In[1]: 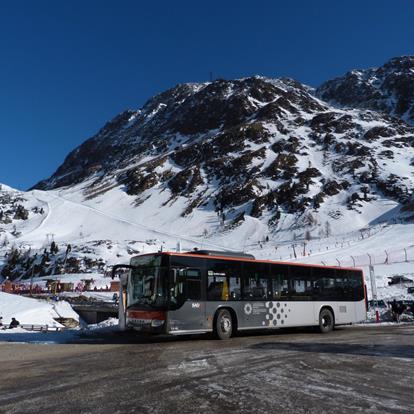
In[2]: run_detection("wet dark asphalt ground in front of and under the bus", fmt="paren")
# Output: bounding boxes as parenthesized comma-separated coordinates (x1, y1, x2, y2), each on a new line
(0, 324, 414, 414)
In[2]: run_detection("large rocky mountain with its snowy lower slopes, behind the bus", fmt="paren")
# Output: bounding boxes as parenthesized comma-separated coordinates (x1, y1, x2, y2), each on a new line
(0, 57, 414, 300)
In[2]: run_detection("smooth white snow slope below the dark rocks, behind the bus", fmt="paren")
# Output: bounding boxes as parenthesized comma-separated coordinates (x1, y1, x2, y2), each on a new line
(0, 183, 414, 297)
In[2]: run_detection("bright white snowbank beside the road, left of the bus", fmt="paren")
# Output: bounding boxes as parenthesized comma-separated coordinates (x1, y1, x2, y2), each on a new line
(0, 292, 79, 326)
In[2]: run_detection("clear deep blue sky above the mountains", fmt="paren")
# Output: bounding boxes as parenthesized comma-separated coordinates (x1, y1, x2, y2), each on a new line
(0, 0, 414, 189)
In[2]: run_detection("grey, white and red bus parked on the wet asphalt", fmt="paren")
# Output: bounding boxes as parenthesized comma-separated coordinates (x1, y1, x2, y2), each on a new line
(113, 250, 366, 339)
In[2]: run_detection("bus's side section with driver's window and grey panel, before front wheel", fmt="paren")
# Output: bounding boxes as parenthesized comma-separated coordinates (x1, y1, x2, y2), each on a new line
(169, 268, 207, 333)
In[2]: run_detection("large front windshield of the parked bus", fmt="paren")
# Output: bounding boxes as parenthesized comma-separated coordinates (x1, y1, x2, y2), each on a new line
(127, 256, 167, 307)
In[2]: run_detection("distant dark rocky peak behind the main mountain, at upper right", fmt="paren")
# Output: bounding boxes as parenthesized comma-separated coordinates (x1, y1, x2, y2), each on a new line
(316, 56, 414, 124)
